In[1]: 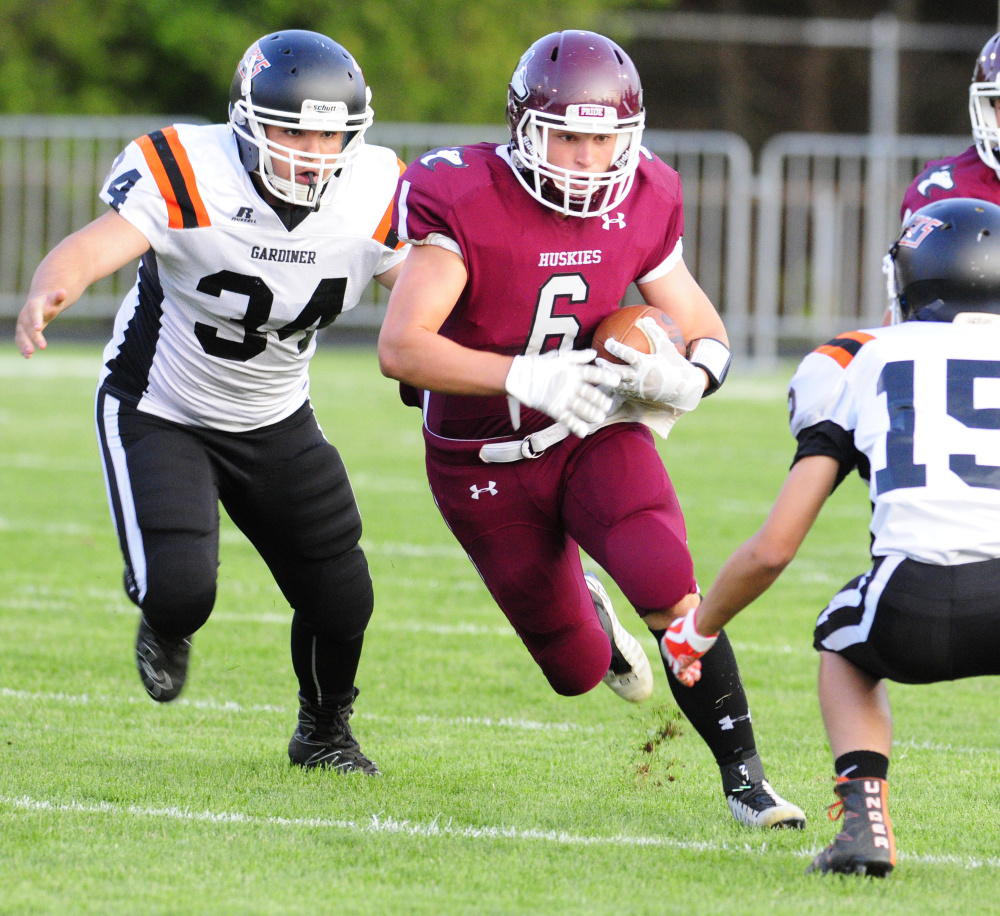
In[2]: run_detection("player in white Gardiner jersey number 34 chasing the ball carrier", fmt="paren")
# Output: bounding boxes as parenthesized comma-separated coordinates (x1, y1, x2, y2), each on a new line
(16, 30, 406, 774)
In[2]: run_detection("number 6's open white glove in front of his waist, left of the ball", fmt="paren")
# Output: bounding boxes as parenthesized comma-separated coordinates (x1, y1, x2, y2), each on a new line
(505, 350, 621, 439)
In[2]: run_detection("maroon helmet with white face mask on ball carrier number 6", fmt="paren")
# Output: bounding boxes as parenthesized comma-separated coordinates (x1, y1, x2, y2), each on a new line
(507, 32, 646, 216)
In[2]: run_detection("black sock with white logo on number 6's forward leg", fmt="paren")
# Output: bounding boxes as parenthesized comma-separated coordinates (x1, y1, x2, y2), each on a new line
(650, 629, 757, 767)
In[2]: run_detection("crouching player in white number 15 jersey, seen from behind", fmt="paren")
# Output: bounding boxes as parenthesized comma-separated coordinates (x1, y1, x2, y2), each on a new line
(664, 198, 1000, 876)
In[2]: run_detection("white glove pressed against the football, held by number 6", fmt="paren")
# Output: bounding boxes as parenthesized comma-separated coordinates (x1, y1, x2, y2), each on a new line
(601, 318, 705, 411)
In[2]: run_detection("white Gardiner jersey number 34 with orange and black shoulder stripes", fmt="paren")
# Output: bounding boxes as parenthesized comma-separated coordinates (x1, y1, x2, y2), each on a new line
(94, 124, 406, 432)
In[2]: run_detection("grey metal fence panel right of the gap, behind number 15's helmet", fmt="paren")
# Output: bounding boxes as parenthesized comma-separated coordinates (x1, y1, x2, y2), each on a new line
(751, 134, 970, 361)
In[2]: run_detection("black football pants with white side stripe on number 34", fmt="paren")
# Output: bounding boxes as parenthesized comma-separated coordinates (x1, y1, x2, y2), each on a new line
(96, 390, 374, 701)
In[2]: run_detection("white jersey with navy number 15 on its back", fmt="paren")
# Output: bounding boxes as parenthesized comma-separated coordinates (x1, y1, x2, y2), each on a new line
(789, 315, 1000, 565)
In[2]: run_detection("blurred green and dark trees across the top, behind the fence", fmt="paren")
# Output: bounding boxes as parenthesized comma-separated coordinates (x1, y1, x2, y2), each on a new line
(0, 0, 997, 143)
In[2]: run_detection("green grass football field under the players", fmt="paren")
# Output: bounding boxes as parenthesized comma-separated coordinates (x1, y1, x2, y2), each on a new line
(0, 340, 1000, 916)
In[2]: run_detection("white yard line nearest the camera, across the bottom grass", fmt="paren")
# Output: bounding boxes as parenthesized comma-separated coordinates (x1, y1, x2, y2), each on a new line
(0, 795, 1000, 869)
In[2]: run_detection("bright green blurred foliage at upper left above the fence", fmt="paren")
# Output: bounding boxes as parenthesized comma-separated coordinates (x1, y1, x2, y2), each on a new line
(0, 0, 675, 123)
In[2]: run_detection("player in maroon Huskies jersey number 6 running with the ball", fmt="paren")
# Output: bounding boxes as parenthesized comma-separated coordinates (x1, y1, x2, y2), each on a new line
(379, 31, 805, 827)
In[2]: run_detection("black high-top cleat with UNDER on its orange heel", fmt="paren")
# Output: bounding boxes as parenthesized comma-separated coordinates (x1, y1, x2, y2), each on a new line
(806, 778, 896, 878)
